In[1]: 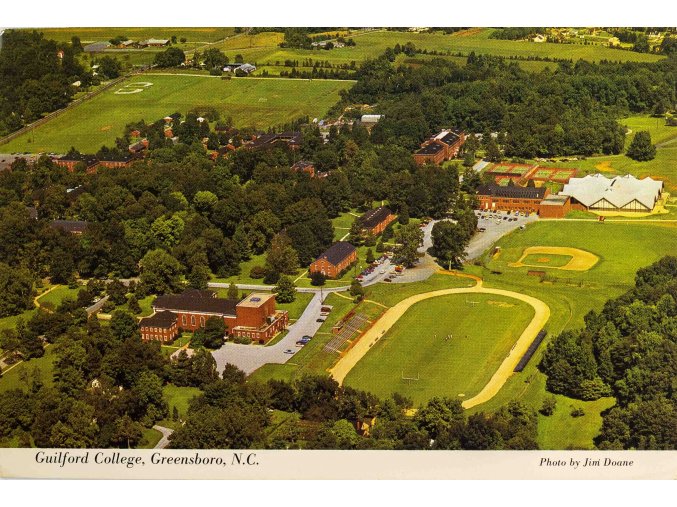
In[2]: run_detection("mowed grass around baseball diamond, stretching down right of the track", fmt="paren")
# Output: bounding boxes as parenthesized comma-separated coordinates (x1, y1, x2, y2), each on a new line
(466, 221, 677, 449)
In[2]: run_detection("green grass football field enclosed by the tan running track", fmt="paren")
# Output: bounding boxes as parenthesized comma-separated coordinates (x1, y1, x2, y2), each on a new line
(345, 294, 534, 403)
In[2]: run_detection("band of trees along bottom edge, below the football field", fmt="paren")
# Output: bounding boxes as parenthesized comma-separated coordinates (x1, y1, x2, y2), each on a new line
(170, 372, 537, 449)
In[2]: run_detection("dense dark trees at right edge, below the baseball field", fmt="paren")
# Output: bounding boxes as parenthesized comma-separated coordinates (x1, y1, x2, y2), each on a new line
(540, 257, 677, 449)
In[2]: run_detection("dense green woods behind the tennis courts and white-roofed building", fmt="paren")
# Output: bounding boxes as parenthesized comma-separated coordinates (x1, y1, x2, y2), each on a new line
(343, 54, 676, 158)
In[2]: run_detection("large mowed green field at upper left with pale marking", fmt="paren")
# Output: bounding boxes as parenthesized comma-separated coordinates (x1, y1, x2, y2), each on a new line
(1, 74, 352, 153)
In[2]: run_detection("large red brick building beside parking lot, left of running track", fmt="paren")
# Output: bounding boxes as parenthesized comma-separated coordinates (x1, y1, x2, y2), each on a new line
(148, 291, 289, 343)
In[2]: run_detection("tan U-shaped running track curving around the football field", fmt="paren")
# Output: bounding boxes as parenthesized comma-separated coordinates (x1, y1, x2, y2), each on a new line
(330, 272, 550, 408)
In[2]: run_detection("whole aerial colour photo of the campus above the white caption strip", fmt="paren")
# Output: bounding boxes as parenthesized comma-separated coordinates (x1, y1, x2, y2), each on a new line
(0, 27, 677, 450)
